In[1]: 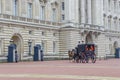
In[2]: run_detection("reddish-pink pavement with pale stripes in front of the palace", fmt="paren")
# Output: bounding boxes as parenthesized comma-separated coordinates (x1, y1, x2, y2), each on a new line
(0, 59, 120, 80)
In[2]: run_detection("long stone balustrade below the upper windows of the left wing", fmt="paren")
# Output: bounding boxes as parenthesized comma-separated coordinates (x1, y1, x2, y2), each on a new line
(0, 14, 62, 27)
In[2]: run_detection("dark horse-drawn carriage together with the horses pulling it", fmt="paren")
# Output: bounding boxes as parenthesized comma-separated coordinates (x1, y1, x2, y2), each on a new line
(69, 44, 96, 63)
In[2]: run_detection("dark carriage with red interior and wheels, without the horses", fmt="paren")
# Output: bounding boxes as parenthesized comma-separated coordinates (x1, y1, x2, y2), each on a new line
(76, 44, 96, 63)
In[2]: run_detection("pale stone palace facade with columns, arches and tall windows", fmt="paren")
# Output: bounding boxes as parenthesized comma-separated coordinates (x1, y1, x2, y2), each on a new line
(0, 0, 120, 60)
